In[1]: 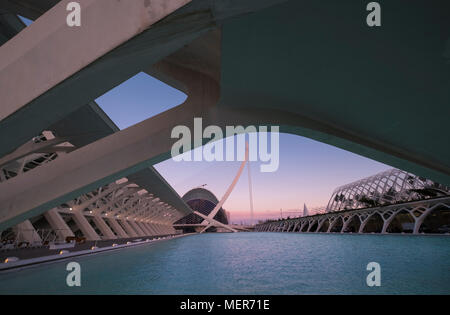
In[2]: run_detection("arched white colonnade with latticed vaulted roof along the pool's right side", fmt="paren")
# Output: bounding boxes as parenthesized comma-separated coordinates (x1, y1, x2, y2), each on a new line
(255, 169, 450, 234)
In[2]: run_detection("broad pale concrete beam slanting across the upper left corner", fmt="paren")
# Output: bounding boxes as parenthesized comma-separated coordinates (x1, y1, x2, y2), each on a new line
(0, 0, 191, 128)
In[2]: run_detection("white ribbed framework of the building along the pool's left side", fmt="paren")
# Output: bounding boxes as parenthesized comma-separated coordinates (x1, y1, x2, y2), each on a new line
(0, 131, 184, 244)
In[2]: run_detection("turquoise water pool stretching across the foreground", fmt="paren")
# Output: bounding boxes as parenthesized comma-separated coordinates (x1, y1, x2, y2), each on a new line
(0, 233, 450, 294)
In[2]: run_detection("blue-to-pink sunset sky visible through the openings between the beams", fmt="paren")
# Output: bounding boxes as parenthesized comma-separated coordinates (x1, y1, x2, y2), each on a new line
(96, 73, 389, 223)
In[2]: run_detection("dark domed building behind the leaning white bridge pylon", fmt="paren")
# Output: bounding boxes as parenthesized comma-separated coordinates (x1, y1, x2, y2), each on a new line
(174, 188, 228, 233)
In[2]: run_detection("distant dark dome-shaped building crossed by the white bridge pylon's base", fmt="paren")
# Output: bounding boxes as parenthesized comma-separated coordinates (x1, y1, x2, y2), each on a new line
(175, 188, 228, 231)
